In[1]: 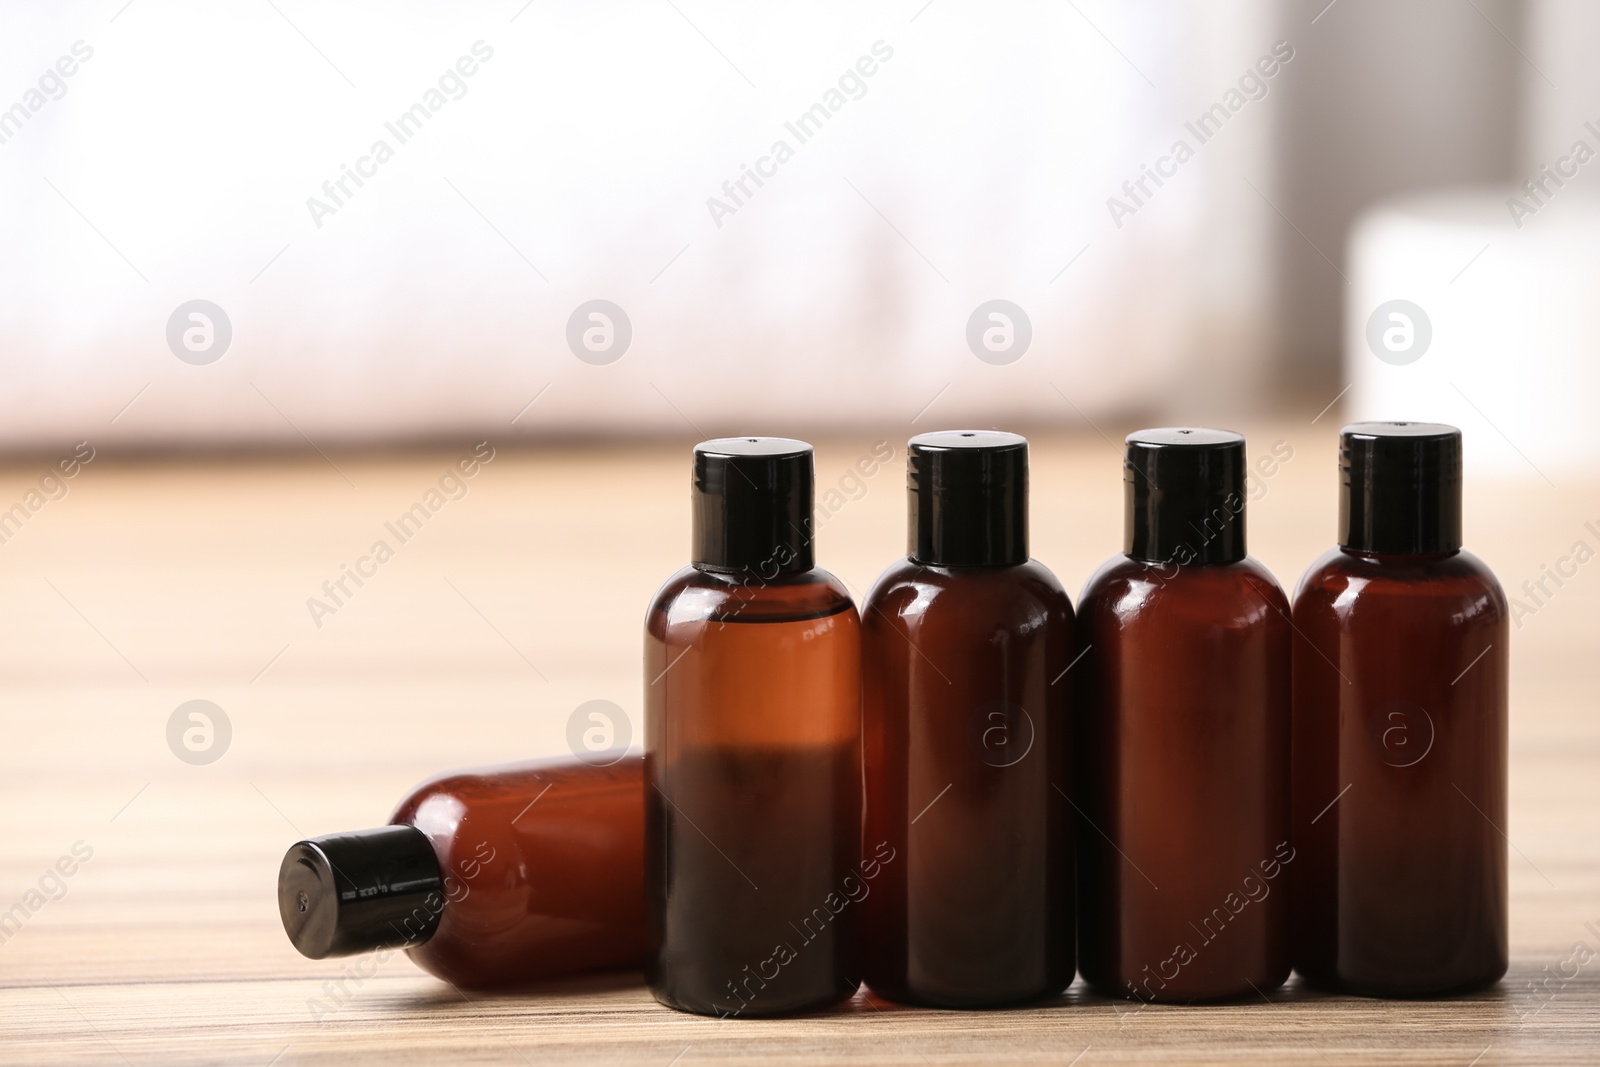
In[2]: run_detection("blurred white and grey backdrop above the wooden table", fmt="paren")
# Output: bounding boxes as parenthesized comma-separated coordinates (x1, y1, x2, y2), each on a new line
(0, 0, 1600, 467)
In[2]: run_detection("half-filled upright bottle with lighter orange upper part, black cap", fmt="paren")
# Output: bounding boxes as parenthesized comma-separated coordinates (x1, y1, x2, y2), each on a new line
(645, 437, 877, 1017)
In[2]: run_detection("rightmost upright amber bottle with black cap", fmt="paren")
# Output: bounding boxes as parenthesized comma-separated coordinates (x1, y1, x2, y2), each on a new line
(1294, 422, 1510, 997)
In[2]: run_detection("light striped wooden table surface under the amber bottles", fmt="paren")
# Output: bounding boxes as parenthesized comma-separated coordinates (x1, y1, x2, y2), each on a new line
(0, 414, 1600, 1067)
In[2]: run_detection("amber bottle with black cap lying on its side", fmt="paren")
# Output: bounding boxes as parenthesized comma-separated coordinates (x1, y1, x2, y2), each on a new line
(278, 757, 645, 989)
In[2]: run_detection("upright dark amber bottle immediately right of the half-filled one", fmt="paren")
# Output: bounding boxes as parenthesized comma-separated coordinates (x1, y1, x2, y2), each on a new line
(861, 430, 1074, 1008)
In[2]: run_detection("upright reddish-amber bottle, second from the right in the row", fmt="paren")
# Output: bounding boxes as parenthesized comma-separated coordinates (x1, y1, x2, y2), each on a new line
(1069, 429, 1298, 1003)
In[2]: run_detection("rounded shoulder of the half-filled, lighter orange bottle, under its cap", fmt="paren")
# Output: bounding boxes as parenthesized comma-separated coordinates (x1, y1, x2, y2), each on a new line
(645, 565, 856, 635)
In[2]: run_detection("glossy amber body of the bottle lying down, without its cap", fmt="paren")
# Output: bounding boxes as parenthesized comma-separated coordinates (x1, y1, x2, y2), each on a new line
(390, 755, 645, 989)
